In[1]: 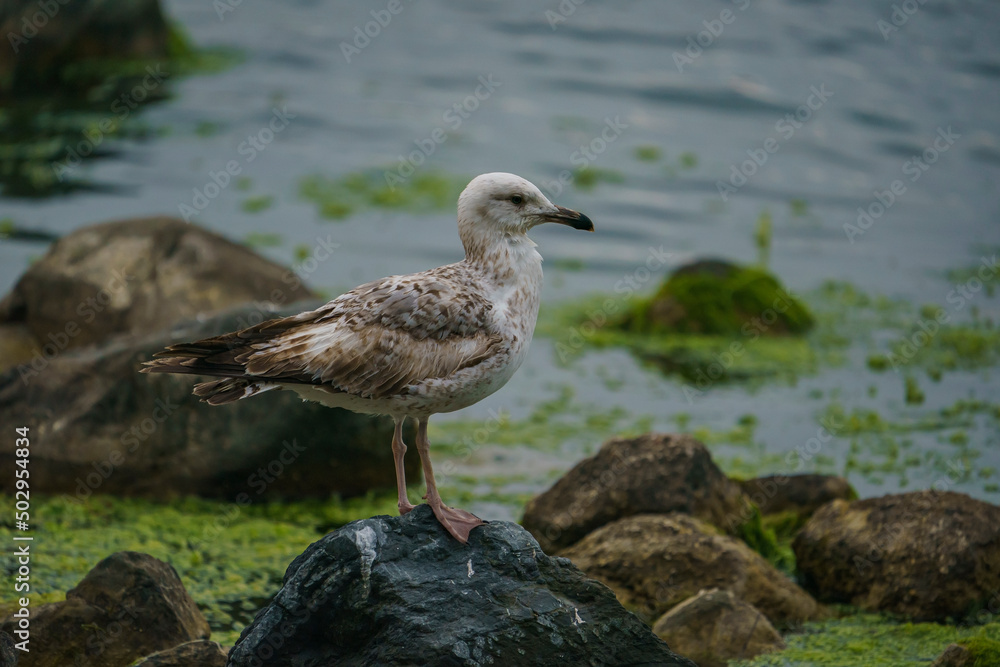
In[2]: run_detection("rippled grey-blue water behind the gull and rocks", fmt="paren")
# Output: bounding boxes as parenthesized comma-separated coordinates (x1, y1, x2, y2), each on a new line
(0, 0, 1000, 516)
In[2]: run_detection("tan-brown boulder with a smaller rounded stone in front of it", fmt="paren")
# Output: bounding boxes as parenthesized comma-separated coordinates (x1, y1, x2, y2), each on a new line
(562, 513, 825, 627)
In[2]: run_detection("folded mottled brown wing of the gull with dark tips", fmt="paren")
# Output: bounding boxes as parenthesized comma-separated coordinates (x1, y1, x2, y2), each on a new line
(143, 265, 503, 400)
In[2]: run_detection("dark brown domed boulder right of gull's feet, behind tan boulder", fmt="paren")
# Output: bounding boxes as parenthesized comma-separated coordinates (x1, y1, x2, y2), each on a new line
(522, 433, 751, 553)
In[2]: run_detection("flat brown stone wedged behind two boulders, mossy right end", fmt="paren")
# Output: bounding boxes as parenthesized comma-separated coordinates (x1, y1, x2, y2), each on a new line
(739, 474, 858, 519)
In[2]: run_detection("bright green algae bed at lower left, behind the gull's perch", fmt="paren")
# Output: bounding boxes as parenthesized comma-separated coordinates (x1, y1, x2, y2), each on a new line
(0, 489, 402, 645)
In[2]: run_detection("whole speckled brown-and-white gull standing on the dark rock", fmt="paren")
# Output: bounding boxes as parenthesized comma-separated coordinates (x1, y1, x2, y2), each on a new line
(141, 173, 594, 544)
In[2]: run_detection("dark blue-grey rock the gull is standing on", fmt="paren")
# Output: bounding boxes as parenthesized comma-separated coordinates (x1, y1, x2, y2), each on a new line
(229, 505, 693, 667)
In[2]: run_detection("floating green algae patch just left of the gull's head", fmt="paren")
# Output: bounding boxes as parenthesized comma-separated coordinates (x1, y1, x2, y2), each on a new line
(299, 169, 469, 220)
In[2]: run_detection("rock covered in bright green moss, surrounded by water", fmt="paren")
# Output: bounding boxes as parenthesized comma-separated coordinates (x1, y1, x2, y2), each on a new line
(620, 259, 815, 336)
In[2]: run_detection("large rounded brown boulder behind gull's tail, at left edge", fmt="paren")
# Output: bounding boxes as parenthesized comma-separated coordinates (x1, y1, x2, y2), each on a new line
(0, 217, 315, 370)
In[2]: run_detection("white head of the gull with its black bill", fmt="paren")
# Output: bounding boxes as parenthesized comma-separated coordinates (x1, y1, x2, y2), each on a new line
(458, 172, 594, 249)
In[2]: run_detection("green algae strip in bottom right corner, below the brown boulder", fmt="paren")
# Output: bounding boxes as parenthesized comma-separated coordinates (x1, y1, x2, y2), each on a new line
(730, 613, 1000, 667)
